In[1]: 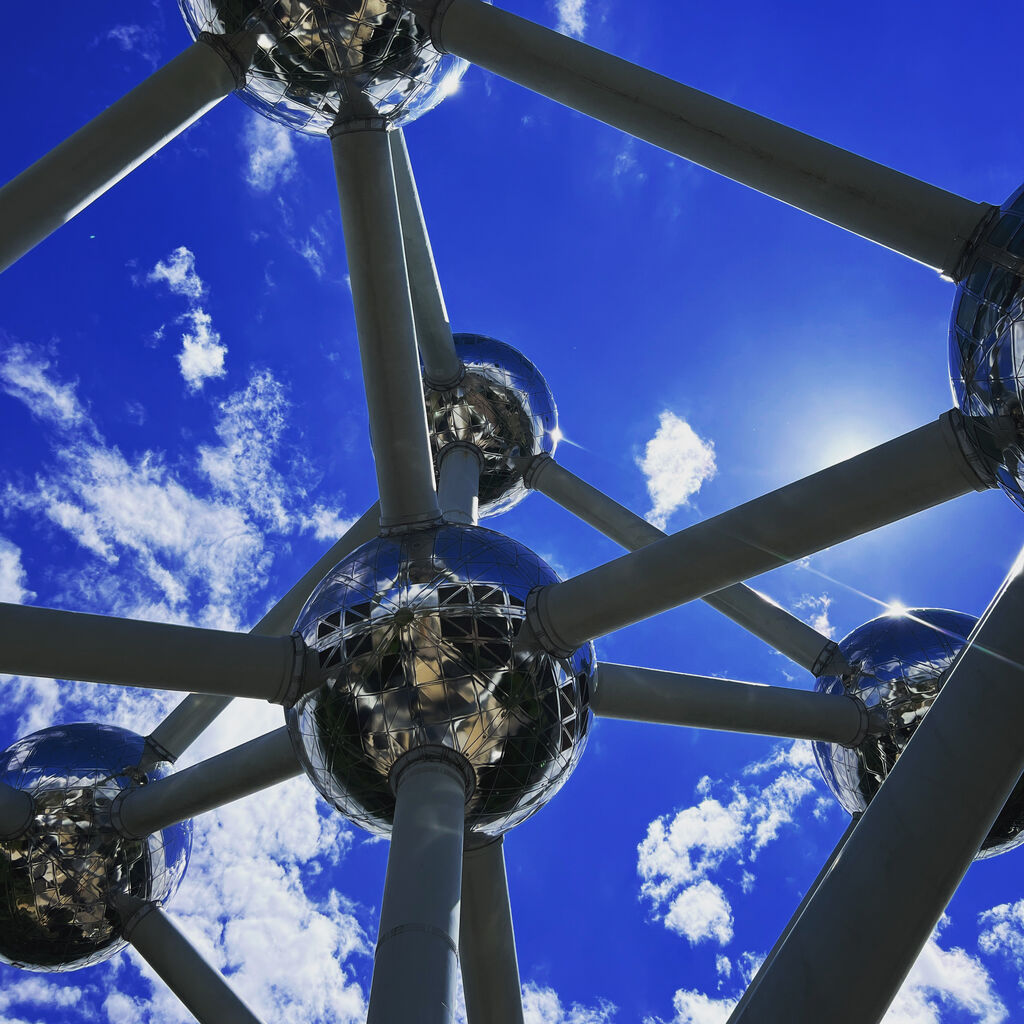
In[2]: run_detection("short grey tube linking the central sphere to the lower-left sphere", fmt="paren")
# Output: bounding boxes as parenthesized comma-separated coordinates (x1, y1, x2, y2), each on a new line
(114, 727, 302, 838)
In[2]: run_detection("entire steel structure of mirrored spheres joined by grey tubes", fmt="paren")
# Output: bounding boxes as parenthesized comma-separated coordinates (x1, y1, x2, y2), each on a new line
(0, 0, 1024, 1024)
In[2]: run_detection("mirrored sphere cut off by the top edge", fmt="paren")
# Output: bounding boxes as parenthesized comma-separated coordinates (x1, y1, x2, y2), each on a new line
(178, 0, 467, 135)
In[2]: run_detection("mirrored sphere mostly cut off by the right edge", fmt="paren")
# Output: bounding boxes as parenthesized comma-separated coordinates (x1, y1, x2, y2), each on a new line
(949, 188, 1024, 508)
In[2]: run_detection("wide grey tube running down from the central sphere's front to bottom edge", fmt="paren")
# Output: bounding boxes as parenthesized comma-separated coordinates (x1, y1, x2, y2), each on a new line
(367, 751, 468, 1024)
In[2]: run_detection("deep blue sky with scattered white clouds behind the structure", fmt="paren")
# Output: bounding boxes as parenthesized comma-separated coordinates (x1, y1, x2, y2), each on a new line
(0, 0, 1024, 1024)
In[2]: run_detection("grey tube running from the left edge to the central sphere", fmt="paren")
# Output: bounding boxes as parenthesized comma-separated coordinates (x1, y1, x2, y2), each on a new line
(0, 604, 297, 700)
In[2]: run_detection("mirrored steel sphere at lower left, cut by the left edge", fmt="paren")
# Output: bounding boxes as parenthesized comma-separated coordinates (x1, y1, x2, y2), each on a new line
(0, 724, 191, 972)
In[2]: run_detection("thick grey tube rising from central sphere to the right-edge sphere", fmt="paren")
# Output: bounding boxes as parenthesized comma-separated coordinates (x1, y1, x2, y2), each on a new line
(519, 412, 991, 653)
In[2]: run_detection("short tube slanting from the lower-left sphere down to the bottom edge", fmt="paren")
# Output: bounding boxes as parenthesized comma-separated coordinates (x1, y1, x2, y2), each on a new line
(124, 903, 260, 1024)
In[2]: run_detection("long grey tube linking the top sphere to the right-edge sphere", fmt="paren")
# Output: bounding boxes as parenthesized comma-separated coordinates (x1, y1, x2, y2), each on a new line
(414, 0, 992, 276)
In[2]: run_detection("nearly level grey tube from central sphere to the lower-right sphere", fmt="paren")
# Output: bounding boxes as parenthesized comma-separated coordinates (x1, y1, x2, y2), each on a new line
(591, 662, 868, 746)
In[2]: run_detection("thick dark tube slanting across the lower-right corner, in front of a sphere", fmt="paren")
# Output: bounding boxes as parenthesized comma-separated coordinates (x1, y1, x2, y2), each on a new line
(730, 553, 1024, 1024)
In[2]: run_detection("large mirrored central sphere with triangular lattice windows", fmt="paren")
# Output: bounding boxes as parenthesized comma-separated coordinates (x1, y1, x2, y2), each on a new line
(287, 524, 594, 836)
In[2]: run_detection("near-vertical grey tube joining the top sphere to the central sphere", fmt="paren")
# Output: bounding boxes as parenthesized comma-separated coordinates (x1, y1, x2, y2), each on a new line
(331, 122, 440, 527)
